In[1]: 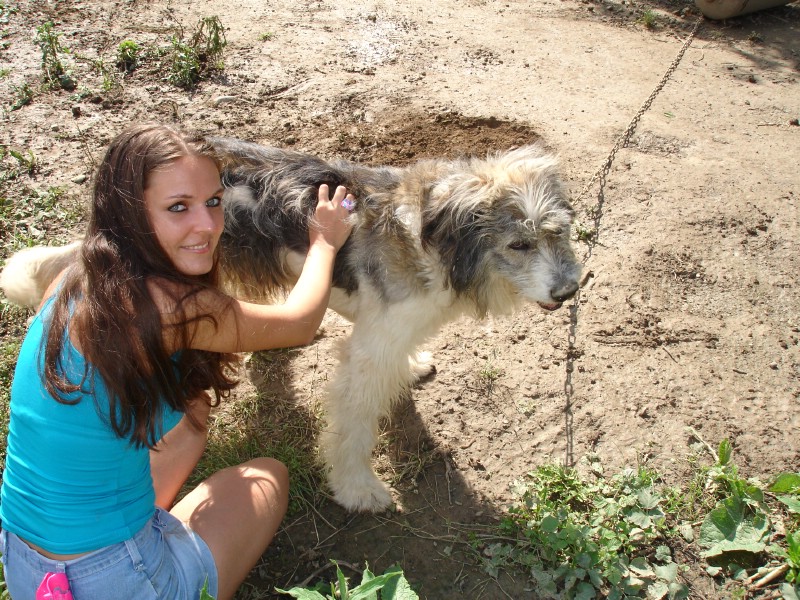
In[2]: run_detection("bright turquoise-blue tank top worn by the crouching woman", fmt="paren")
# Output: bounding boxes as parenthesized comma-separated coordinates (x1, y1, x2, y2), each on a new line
(0, 298, 183, 554)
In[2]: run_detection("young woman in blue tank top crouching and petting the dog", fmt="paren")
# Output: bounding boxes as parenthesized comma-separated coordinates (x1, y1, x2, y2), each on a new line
(0, 125, 352, 600)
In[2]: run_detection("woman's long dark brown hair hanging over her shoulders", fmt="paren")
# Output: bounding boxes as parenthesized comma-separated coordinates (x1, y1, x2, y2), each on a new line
(43, 124, 236, 448)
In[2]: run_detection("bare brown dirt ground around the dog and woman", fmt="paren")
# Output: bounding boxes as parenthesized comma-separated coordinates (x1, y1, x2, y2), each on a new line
(0, 0, 800, 599)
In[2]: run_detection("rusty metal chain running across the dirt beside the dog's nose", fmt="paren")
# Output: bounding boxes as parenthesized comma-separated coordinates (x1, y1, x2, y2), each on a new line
(564, 15, 703, 466)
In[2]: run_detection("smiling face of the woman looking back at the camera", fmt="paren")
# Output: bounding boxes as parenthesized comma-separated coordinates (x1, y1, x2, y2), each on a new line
(144, 156, 223, 275)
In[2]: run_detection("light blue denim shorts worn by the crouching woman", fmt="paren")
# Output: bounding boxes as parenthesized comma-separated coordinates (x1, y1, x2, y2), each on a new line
(0, 508, 217, 600)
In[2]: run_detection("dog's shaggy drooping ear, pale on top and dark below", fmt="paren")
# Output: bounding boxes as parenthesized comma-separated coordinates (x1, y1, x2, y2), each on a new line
(420, 173, 494, 294)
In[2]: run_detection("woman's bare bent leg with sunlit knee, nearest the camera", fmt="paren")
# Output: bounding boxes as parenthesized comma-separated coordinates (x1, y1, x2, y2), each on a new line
(170, 458, 289, 600)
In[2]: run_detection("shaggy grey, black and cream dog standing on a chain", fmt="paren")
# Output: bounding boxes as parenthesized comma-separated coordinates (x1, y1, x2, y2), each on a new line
(0, 138, 581, 511)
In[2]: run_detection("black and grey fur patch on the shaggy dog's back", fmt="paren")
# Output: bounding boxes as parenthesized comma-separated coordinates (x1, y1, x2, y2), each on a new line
(212, 138, 398, 292)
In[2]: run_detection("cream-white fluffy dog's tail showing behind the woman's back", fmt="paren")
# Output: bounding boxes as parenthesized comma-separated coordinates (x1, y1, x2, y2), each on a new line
(0, 242, 80, 308)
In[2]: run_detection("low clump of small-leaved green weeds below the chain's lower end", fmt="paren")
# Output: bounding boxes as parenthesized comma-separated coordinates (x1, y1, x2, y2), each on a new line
(482, 458, 688, 598)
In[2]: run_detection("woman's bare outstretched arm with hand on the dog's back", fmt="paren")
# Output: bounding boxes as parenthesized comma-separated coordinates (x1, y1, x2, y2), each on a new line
(154, 185, 351, 352)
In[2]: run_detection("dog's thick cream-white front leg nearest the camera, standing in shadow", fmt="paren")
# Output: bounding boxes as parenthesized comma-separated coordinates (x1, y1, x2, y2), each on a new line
(320, 323, 411, 512)
